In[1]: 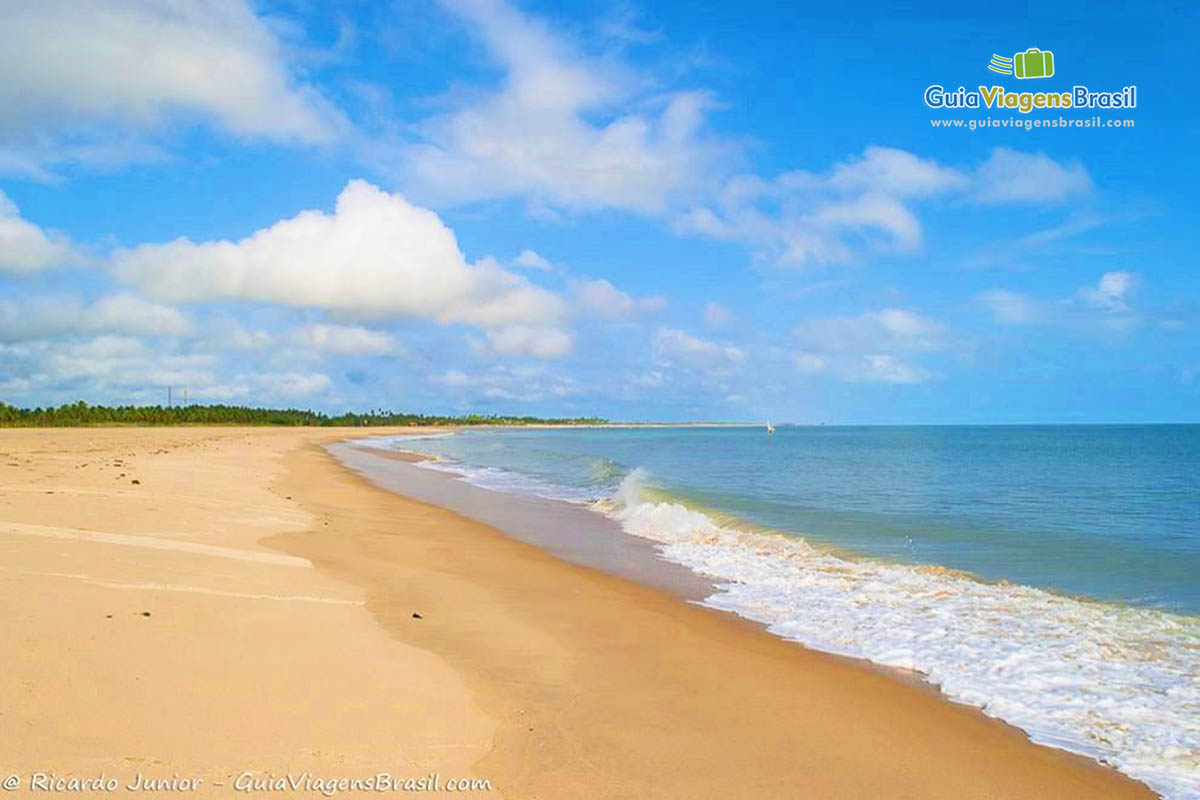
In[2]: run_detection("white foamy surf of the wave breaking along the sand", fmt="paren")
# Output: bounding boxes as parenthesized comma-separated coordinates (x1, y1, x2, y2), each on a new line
(595, 470, 1200, 800)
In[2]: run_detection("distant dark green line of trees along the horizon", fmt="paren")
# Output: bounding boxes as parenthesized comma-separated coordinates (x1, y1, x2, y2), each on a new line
(0, 401, 607, 428)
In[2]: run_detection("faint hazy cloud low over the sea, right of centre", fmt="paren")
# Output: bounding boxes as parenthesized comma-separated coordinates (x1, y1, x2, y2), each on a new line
(793, 308, 952, 384)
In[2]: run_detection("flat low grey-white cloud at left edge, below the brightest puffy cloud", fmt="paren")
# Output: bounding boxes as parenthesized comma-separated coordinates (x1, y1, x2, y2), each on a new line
(0, 294, 192, 342)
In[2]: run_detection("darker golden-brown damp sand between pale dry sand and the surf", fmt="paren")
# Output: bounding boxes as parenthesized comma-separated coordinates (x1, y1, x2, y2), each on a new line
(280, 438, 1153, 799)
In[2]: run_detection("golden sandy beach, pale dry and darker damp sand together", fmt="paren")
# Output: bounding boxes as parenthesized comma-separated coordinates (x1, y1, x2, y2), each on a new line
(0, 428, 1153, 800)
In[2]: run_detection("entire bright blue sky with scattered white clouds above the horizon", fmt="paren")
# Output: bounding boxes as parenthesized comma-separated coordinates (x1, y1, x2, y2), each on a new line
(0, 0, 1200, 423)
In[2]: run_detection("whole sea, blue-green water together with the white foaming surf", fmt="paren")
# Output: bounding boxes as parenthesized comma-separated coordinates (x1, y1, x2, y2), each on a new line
(360, 426, 1200, 800)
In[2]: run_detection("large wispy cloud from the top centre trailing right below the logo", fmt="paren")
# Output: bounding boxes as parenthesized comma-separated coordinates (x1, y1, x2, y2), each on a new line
(380, 0, 1091, 275)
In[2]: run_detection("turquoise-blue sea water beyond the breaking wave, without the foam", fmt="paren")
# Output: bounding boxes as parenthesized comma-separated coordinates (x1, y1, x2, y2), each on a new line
(408, 426, 1200, 614)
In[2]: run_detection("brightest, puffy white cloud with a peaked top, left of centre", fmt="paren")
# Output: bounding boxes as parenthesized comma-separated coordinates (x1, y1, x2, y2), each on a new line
(113, 180, 566, 336)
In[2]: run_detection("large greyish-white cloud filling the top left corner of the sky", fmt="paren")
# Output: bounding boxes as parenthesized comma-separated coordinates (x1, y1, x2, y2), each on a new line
(0, 0, 342, 176)
